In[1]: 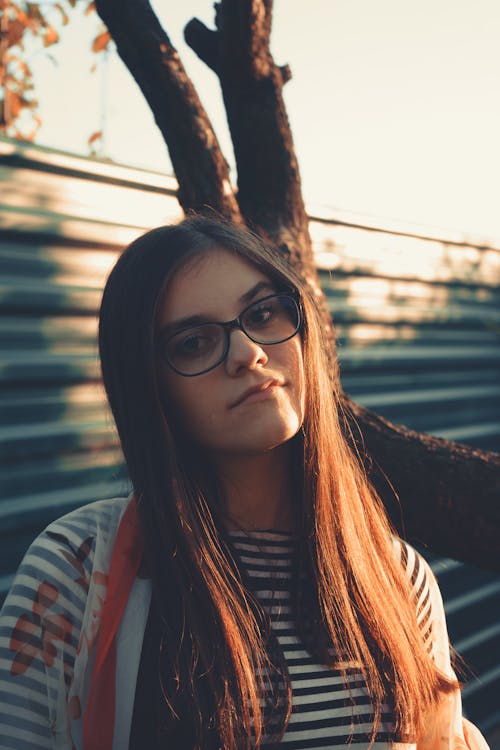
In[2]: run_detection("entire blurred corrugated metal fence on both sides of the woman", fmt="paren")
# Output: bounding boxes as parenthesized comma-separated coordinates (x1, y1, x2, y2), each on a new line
(0, 140, 500, 744)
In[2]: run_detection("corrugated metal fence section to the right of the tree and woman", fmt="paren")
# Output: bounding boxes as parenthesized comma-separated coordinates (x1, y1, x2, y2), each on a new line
(311, 221, 500, 750)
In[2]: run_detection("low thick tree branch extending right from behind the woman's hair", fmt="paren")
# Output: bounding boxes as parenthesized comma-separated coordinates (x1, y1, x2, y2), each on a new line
(344, 398, 500, 570)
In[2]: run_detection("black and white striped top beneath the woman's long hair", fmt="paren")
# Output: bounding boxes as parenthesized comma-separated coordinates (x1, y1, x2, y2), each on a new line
(231, 531, 431, 750)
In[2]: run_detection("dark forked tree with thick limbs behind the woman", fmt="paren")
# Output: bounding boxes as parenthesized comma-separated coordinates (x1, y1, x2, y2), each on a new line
(1, 0, 500, 570)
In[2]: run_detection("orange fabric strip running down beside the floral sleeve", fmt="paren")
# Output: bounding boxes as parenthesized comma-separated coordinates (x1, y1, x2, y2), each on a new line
(83, 498, 143, 750)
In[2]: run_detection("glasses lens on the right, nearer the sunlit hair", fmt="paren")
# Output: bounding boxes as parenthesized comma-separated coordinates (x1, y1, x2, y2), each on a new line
(241, 294, 300, 344)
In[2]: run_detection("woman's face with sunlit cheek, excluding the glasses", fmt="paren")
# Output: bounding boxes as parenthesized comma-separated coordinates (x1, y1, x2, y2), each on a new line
(157, 249, 305, 457)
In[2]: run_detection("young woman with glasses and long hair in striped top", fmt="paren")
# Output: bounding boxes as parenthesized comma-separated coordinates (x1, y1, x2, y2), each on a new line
(0, 218, 486, 750)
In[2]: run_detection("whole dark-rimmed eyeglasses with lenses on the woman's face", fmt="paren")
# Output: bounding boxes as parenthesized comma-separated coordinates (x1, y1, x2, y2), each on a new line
(160, 294, 301, 378)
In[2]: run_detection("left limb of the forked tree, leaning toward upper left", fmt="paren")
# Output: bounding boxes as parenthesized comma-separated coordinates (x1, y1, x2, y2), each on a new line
(96, 0, 241, 223)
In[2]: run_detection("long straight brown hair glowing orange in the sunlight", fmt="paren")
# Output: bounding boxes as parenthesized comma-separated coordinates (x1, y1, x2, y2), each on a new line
(99, 217, 454, 750)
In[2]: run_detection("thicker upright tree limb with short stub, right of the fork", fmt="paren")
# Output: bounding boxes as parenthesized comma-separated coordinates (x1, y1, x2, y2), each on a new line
(187, 0, 302, 251)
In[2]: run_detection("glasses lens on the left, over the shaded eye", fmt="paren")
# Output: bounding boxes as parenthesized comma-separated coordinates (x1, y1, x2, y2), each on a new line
(165, 323, 225, 375)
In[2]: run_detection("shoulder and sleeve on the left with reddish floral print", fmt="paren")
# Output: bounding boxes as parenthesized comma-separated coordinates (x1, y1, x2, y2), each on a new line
(0, 498, 132, 748)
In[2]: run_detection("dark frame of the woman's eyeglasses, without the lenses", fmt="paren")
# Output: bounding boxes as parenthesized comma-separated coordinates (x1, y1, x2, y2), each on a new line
(159, 292, 303, 378)
